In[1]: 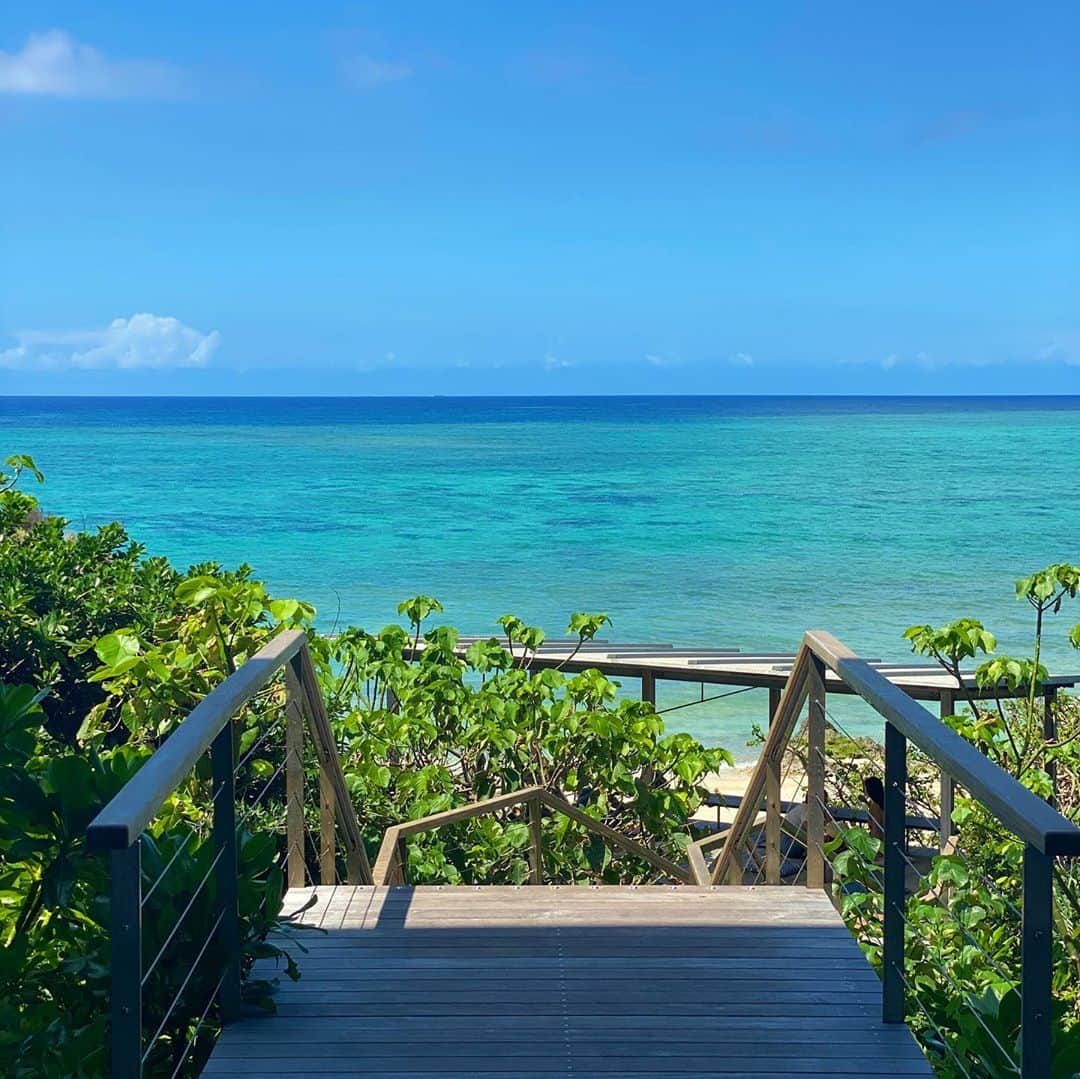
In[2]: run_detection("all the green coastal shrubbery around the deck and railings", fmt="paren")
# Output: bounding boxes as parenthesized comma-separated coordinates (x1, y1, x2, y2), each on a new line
(0, 457, 1080, 1077)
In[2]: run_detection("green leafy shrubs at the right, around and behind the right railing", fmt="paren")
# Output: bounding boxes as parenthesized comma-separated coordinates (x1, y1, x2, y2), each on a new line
(831, 563, 1080, 1077)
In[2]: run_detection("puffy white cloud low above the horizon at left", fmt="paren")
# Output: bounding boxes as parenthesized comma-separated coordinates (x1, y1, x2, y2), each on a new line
(0, 314, 221, 370)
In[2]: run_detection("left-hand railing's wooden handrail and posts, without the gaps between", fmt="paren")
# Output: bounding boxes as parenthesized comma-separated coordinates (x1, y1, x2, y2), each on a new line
(87, 630, 372, 1079)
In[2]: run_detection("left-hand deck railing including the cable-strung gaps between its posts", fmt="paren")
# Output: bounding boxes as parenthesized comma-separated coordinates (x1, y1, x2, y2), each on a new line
(87, 631, 372, 1079)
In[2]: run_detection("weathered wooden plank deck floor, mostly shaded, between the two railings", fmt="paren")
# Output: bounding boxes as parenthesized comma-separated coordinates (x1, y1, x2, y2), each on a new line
(204, 886, 931, 1079)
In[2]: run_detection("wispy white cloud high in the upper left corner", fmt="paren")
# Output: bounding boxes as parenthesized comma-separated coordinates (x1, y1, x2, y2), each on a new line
(0, 30, 184, 98)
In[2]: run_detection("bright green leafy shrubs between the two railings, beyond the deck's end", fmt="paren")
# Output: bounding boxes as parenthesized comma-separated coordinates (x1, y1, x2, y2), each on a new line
(322, 597, 731, 884)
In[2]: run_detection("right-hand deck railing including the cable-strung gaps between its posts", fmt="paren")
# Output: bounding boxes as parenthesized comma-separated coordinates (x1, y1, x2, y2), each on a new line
(689, 632, 1080, 1079)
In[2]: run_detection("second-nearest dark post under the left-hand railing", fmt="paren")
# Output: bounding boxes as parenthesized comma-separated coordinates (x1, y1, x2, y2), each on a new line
(211, 723, 240, 1023)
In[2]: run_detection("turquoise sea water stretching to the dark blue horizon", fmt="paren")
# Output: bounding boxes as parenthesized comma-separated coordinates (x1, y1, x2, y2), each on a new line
(0, 397, 1080, 757)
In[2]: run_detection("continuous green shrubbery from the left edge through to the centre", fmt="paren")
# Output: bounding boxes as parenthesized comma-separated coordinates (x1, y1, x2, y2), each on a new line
(0, 457, 730, 1076)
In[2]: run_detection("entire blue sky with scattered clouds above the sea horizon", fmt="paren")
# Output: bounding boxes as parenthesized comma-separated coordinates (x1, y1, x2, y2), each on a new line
(0, 0, 1080, 393)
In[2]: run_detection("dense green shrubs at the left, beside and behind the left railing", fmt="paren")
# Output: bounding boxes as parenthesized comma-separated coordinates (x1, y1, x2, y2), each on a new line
(0, 458, 313, 1076)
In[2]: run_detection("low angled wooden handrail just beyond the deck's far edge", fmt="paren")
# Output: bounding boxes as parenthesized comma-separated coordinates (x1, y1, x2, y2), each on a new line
(374, 786, 690, 885)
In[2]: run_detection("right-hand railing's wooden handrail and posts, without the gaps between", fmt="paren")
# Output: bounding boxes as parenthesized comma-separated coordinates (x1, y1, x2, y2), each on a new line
(688, 631, 1080, 1079)
